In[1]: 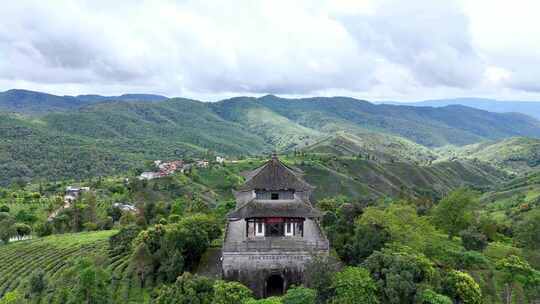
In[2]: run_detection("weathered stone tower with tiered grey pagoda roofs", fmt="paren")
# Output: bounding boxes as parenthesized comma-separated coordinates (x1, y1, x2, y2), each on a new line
(222, 155, 329, 297)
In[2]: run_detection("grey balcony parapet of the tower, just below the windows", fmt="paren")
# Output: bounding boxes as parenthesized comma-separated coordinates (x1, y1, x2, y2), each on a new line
(223, 237, 329, 252)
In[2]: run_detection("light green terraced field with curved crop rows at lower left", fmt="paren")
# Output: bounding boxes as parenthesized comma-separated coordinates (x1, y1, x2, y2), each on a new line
(0, 230, 154, 303)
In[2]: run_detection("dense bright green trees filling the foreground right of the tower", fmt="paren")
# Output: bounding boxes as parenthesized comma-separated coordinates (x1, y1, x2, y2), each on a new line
(317, 189, 540, 303)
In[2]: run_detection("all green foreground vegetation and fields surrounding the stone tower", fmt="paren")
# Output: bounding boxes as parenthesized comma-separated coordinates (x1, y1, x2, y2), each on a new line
(0, 155, 540, 304)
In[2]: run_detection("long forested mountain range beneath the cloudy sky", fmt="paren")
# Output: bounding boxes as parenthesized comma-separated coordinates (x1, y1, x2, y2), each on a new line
(0, 90, 540, 184)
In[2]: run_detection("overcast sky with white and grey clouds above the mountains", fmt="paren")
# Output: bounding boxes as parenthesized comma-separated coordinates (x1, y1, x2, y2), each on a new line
(0, 0, 540, 100)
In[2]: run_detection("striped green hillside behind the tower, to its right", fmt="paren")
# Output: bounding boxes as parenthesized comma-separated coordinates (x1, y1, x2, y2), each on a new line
(299, 158, 507, 199)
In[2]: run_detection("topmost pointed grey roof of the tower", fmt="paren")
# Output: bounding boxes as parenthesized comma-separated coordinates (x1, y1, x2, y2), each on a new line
(238, 154, 313, 191)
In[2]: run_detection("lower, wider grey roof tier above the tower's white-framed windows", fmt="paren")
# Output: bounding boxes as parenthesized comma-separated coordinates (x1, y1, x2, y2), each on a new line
(227, 199, 321, 219)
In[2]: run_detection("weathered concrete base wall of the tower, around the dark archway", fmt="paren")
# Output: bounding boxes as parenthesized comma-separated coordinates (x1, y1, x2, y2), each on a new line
(222, 251, 320, 298)
